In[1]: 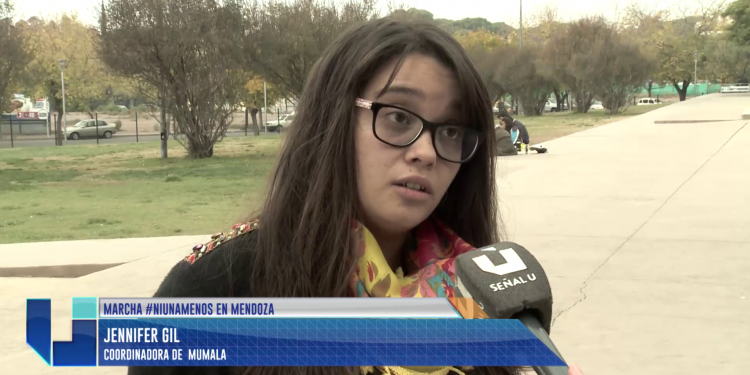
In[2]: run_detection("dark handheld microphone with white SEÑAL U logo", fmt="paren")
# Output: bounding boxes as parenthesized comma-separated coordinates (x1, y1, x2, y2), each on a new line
(454, 242, 568, 375)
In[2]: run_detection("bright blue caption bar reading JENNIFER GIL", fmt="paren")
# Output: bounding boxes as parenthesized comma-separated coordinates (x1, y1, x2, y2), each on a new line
(98, 318, 565, 366)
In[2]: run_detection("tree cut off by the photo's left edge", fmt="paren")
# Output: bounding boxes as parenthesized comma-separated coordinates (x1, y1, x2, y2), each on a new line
(0, 0, 32, 114)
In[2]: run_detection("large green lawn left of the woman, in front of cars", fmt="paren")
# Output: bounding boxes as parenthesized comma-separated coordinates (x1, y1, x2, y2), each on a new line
(0, 137, 281, 243)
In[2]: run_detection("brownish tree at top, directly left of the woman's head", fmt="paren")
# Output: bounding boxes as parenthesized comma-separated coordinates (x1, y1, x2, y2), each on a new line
(244, 0, 377, 99)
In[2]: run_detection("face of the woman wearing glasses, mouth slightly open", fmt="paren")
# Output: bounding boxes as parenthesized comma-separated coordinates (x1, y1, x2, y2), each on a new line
(355, 54, 462, 235)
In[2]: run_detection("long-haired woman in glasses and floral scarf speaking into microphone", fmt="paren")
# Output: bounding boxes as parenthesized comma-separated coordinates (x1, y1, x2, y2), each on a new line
(129, 19, 584, 375)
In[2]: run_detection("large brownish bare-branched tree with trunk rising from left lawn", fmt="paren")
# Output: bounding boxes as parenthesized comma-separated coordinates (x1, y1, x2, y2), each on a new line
(99, 0, 246, 158)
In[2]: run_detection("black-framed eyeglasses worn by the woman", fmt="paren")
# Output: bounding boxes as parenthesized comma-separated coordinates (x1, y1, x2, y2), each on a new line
(354, 98, 483, 163)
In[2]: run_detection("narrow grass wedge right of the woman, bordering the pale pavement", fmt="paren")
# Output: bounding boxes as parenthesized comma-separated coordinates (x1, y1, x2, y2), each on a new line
(506, 104, 667, 144)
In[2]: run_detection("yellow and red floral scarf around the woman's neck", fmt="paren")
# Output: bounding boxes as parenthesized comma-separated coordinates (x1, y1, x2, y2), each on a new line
(351, 219, 486, 375)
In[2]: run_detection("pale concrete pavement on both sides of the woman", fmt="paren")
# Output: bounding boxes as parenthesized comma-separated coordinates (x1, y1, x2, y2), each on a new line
(0, 94, 750, 375)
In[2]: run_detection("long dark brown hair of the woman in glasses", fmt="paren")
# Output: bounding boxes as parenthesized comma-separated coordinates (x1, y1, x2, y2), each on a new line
(246, 18, 514, 375)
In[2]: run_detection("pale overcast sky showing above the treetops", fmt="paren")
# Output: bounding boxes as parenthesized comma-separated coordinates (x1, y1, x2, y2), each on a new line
(15, 0, 694, 26)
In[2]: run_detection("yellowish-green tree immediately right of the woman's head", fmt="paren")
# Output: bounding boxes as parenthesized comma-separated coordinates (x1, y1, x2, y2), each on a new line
(455, 29, 507, 103)
